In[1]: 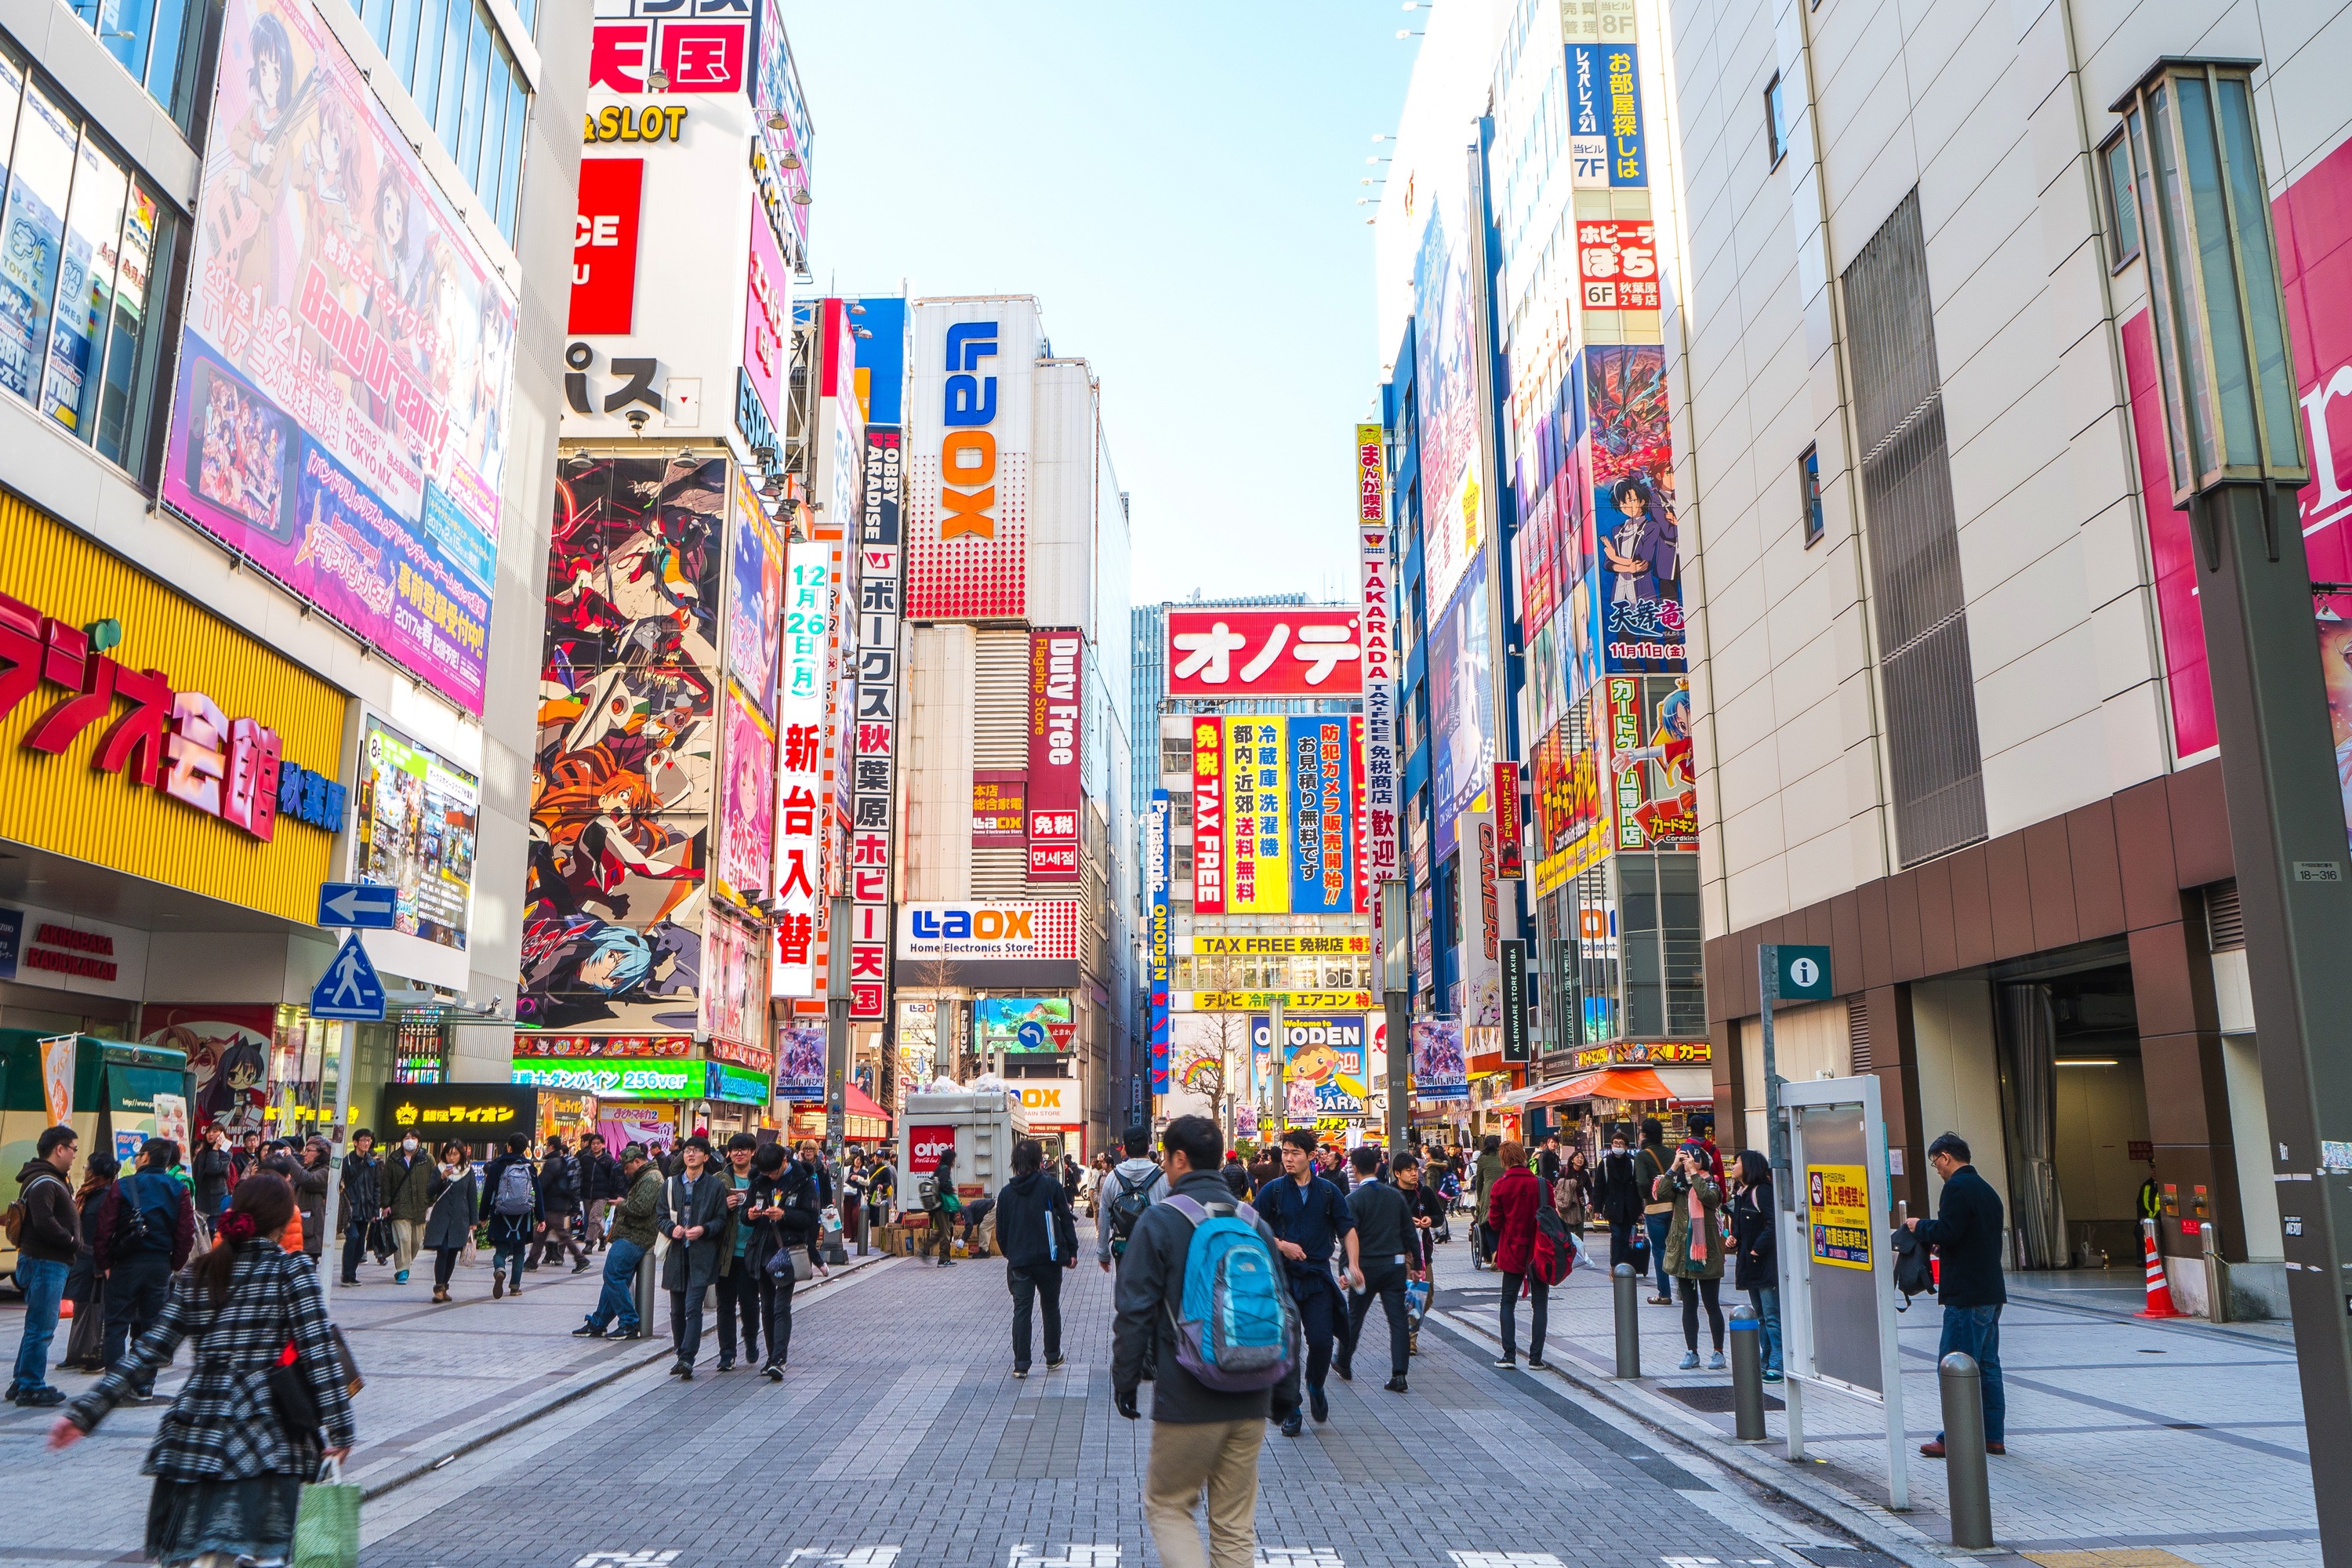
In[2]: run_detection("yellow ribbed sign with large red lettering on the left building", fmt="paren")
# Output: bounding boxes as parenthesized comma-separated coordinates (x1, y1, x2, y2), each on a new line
(0, 492, 346, 924)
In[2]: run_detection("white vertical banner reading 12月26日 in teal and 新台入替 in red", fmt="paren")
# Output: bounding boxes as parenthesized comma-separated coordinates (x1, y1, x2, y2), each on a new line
(769, 541, 833, 996)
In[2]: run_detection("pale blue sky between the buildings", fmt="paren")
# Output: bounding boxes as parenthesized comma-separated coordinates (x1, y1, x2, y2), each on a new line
(783, 0, 1421, 604)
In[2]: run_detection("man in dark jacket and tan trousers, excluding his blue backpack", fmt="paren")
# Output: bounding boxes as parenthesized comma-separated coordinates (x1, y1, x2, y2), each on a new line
(1110, 1116, 1305, 1568)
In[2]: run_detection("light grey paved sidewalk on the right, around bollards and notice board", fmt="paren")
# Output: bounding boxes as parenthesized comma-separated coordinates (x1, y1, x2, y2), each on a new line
(1439, 1248, 2319, 1568)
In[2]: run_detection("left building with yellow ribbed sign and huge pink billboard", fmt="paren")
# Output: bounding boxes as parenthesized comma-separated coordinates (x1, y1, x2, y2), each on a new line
(0, 0, 588, 1147)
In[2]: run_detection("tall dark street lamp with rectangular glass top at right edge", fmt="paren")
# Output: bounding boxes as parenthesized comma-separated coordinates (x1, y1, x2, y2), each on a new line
(2112, 59, 2352, 1561)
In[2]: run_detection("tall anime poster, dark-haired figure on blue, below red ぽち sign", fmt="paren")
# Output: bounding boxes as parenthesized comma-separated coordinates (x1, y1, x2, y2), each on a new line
(1571, 343, 1684, 675)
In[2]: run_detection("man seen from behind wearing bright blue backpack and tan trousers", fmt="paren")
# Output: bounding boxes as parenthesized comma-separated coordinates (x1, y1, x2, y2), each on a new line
(1110, 1116, 1298, 1568)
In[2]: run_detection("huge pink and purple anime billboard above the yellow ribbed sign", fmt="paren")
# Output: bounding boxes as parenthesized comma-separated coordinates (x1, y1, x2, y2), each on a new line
(162, 0, 515, 715)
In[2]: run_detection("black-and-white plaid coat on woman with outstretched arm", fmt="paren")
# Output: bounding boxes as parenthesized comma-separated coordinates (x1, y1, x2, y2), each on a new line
(64, 1236, 358, 1481)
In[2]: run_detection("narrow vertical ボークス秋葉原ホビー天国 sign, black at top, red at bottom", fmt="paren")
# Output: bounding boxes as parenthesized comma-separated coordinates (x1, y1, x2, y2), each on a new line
(849, 426, 901, 1022)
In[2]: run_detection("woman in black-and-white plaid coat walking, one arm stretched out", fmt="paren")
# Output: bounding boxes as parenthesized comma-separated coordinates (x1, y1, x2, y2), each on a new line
(49, 1171, 355, 1566)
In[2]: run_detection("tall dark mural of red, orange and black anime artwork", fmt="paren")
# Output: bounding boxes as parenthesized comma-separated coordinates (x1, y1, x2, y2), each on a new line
(515, 459, 727, 1032)
